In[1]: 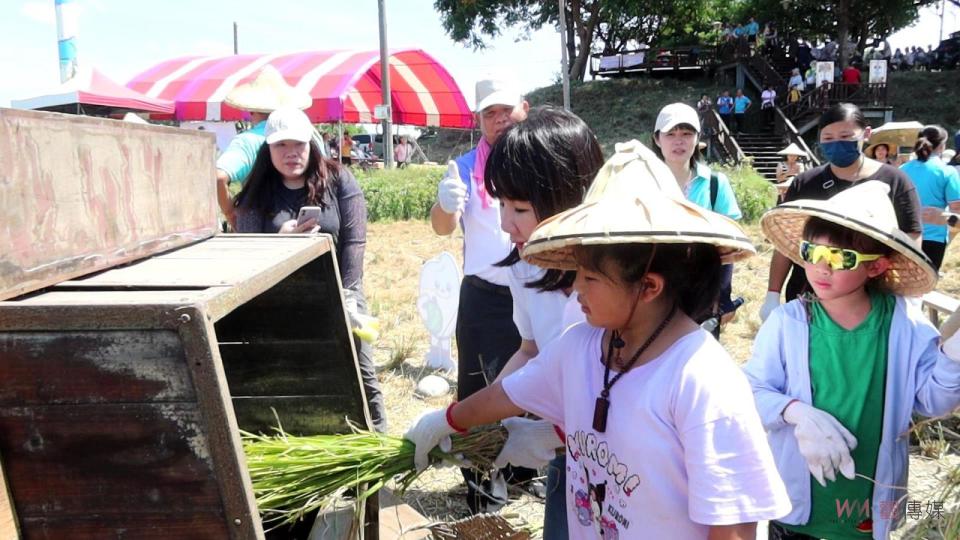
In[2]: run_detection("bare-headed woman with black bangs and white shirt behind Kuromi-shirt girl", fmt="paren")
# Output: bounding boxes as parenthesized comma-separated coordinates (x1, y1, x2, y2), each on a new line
(484, 107, 603, 540)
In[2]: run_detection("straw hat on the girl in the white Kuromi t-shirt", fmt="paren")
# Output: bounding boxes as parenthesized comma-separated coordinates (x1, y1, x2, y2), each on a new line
(521, 140, 756, 270)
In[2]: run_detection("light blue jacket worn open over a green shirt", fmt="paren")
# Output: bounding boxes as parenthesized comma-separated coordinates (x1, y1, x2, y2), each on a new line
(744, 297, 960, 540)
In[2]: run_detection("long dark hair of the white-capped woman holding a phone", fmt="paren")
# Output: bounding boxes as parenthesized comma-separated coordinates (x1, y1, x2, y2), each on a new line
(233, 140, 340, 210)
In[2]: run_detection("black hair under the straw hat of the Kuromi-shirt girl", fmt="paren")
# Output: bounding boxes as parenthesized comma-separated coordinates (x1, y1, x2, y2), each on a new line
(574, 243, 723, 321)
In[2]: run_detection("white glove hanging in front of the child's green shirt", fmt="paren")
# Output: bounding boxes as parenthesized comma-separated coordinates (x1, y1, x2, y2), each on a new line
(783, 401, 857, 487)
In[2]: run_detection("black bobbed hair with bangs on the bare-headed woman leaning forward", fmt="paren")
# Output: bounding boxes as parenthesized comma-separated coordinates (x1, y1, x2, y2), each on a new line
(483, 106, 603, 291)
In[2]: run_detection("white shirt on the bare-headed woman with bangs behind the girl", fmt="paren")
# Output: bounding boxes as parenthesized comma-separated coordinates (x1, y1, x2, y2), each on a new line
(509, 261, 585, 348)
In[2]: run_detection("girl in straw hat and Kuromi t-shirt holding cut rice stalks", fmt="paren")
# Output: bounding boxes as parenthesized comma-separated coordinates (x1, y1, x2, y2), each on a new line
(406, 141, 789, 540)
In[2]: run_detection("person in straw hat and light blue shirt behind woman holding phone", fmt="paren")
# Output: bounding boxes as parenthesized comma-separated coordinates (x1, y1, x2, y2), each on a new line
(217, 65, 313, 227)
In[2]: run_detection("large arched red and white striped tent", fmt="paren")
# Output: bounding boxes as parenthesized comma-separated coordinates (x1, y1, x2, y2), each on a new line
(127, 49, 473, 128)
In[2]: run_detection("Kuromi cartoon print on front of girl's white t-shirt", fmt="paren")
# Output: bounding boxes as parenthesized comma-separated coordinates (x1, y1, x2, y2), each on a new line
(567, 430, 640, 540)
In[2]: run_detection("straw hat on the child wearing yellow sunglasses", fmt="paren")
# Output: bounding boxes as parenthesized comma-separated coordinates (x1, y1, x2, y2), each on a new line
(760, 184, 937, 296)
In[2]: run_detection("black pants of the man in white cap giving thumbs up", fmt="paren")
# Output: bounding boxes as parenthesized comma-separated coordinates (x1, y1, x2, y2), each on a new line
(456, 276, 524, 513)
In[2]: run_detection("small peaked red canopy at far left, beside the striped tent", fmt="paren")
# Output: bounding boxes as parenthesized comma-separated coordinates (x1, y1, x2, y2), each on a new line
(10, 69, 174, 114)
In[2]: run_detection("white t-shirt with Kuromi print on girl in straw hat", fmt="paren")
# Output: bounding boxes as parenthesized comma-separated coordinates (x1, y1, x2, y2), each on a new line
(503, 324, 790, 540)
